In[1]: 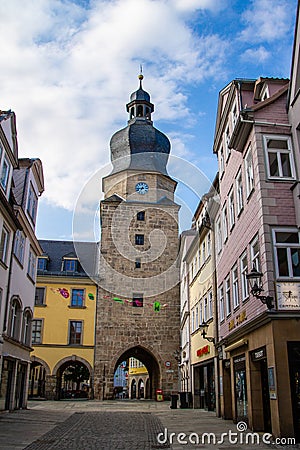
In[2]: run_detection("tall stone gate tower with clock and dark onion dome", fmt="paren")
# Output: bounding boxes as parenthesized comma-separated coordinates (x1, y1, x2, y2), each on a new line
(94, 75, 180, 399)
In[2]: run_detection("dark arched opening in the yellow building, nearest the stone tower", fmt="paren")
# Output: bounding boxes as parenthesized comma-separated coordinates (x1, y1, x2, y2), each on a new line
(52, 355, 93, 400)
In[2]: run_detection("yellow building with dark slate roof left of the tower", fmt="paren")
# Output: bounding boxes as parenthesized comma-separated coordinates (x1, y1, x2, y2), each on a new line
(29, 240, 97, 400)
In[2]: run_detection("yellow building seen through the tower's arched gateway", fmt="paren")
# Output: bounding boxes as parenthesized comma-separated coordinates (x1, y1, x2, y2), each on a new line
(128, 358, 150, 399)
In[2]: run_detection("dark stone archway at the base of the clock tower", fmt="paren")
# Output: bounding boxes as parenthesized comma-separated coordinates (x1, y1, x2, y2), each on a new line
(109, 345, 161, 399)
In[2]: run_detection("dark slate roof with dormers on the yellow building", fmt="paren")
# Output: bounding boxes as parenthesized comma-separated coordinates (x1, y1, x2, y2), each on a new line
(38, 239, 98, 277)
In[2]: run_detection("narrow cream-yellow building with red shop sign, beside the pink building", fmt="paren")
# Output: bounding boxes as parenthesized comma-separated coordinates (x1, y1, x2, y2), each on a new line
(184, 183, 218, 411)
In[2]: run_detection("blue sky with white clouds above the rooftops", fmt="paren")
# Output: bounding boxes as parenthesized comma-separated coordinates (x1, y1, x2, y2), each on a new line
(0, 0, 297, 239)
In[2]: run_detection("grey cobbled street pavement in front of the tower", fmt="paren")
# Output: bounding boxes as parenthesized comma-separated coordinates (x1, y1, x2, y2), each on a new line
(0, 400, 299, 450)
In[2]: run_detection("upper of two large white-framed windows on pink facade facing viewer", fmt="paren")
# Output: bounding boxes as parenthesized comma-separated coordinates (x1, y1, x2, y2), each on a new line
(264, 136, 295, 179)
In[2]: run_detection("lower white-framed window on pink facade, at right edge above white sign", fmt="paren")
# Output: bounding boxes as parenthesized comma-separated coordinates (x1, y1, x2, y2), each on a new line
(273, 228, 300, 278)
